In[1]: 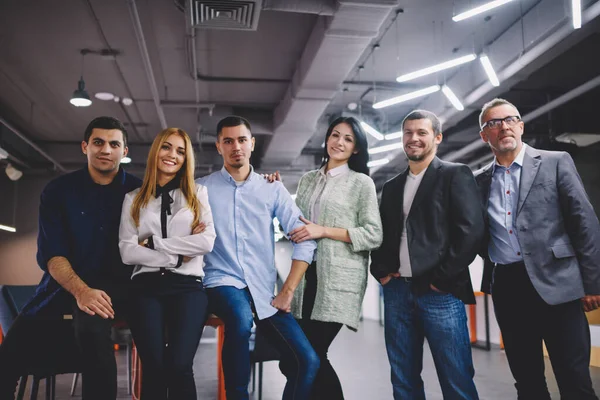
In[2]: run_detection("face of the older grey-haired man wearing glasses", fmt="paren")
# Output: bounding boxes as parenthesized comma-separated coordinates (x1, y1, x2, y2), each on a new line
(479, 104, 525, 154)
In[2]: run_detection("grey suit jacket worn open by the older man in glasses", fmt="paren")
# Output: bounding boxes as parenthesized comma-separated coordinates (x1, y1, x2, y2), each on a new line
(475, 146, 600, 305)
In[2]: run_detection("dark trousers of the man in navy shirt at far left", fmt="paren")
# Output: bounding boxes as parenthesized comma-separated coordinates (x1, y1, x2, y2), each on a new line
(0, 289, 127, 400)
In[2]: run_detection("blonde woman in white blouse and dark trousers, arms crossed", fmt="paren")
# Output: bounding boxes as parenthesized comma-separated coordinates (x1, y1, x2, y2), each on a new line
(119, 128, 215, 400)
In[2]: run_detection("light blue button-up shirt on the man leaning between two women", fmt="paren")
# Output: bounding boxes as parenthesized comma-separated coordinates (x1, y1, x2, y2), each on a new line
(196, 167, 317, 319)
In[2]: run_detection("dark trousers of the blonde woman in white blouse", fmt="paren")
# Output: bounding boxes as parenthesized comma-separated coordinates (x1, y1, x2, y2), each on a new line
(129, 271, 208, 400)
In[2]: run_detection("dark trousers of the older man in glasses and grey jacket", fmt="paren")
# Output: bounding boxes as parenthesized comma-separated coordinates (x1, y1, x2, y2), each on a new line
(492, 263, 597, 400)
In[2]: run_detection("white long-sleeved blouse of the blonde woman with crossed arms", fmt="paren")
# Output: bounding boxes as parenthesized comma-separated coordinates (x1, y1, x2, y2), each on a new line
(119, 184, 216, 277)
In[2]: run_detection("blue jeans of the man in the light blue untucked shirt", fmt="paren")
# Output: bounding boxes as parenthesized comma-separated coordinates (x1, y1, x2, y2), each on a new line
(207, 286, 319, 400)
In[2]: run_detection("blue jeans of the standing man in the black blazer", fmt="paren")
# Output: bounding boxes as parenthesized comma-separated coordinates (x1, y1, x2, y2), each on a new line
(383, 278, 479, 400)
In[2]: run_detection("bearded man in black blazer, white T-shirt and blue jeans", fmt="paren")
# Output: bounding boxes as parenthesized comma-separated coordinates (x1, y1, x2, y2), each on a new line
(371, 110, 484, 400)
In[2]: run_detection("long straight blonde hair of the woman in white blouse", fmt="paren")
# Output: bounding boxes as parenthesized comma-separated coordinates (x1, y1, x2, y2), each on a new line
(131, 128, 200, 229)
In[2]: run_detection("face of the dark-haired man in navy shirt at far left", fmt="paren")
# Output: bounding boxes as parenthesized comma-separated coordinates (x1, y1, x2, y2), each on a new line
(81, 128, 128, 175)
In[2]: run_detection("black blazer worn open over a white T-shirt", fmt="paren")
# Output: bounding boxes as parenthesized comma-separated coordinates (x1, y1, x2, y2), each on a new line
(371, 157, 484, 304)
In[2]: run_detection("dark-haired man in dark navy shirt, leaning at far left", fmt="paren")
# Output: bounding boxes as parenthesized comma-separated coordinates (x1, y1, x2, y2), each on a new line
(0, 117, 141, 400)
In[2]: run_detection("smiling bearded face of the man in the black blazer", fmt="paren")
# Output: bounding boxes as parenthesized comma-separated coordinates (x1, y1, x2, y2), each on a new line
(402, 118, 442, 162)
